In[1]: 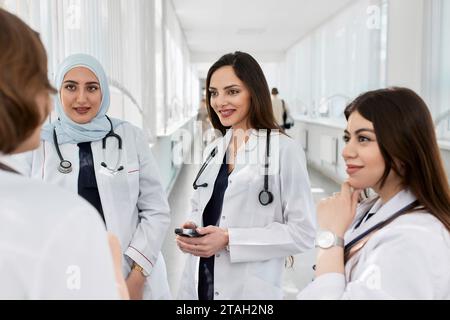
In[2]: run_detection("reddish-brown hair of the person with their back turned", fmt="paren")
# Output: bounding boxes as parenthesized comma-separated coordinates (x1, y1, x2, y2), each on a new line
(0, 9, 56, 154)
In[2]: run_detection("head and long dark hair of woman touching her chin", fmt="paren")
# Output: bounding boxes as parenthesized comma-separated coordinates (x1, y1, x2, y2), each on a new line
(343, 88, 450, 230)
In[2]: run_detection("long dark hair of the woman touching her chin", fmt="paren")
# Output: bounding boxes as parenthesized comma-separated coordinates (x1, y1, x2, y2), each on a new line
(345, 88, 450, 231)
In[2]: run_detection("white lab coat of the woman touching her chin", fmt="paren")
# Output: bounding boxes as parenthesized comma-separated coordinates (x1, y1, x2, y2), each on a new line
(298, 190, 450, 299)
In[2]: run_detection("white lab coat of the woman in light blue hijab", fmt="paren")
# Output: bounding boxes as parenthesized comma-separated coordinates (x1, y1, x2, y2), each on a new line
(9, 122, 171, 299)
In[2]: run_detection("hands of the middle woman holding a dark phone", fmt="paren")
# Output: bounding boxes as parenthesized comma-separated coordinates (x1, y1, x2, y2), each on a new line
(176, 224, 229, 258)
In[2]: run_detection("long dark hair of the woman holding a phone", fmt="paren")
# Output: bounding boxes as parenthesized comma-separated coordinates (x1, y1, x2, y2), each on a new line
(206, 51, 281, 134)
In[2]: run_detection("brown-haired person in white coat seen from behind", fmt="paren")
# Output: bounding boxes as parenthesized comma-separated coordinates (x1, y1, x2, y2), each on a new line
(0, 9, 127, 300)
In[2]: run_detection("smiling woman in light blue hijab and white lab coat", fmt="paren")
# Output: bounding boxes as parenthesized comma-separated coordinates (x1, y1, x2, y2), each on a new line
(11, 54, 171, 299)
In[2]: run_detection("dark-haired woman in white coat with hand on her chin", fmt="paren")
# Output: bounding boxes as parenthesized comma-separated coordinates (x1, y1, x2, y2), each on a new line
(298, 88, 450, 299)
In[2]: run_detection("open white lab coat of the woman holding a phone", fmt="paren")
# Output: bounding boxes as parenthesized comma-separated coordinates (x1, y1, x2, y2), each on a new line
(178, 130, 315, 300)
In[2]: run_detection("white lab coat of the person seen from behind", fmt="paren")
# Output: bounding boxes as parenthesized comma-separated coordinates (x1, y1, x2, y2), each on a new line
(0, 170, 119, 300)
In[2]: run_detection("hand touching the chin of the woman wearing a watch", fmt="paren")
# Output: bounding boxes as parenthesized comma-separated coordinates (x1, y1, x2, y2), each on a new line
(317, 182, 361, 238)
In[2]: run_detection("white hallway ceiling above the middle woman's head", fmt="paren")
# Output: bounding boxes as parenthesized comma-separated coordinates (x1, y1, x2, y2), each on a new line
(172, 0, 356, 62)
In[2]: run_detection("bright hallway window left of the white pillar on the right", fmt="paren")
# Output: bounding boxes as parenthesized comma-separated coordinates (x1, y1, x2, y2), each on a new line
(283, 0, 387, 118)
